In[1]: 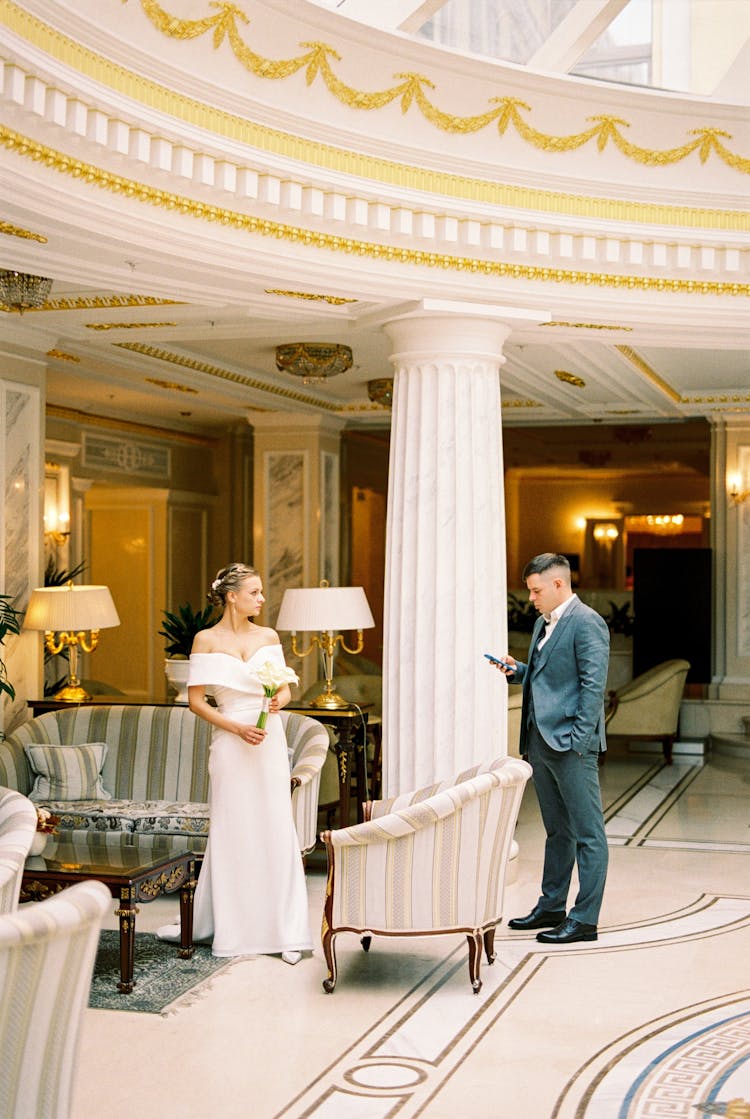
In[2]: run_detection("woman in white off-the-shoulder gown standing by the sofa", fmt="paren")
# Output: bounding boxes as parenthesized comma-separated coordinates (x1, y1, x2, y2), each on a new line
(157, 564, 312, 963)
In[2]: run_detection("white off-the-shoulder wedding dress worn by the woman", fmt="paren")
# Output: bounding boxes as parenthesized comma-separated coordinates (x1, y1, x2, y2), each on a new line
(158, 645, 312, 962)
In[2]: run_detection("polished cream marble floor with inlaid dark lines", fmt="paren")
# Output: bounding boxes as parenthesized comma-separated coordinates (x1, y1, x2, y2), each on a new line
(73, 750, 750, 1119)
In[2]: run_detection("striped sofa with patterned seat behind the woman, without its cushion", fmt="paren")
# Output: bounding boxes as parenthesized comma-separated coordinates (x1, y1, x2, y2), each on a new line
(0, 704, 328, 853)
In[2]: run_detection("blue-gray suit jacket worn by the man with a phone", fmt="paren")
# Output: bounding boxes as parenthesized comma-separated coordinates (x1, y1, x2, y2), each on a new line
(508, 596, 609, 754)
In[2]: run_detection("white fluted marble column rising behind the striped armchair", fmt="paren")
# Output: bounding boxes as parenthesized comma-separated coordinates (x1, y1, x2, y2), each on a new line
(383, 300, 544, 796)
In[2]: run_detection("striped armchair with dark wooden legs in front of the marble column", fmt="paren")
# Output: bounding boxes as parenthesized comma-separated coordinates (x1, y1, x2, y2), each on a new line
(321, 758, 532, 993)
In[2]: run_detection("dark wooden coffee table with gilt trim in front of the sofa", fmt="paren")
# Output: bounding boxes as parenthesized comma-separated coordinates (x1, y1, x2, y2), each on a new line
(20, 835, 199, 995)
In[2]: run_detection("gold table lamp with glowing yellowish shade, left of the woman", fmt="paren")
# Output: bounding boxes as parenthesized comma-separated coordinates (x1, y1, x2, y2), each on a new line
(24, 582, 120, 703)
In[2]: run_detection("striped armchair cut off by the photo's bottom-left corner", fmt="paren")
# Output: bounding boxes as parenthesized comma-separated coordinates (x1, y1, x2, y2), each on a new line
(0, 882, 110, 1119)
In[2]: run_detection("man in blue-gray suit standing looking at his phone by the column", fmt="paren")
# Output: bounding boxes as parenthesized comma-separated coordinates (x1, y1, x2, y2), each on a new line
(499, 552, 609, 944)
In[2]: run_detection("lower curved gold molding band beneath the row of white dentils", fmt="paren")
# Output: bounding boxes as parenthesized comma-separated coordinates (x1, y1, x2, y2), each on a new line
(0, 125, 750, 297)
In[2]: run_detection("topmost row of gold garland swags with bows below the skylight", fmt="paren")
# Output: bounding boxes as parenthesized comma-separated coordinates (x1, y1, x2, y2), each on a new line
(120, 0, 750, 175)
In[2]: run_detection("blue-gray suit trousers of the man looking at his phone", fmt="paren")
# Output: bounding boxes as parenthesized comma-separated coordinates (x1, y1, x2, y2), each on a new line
(526, 714, 609, 924)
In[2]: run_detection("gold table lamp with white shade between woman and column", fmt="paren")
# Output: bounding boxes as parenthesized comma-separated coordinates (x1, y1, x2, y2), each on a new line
(276, 580, 375, 711)
